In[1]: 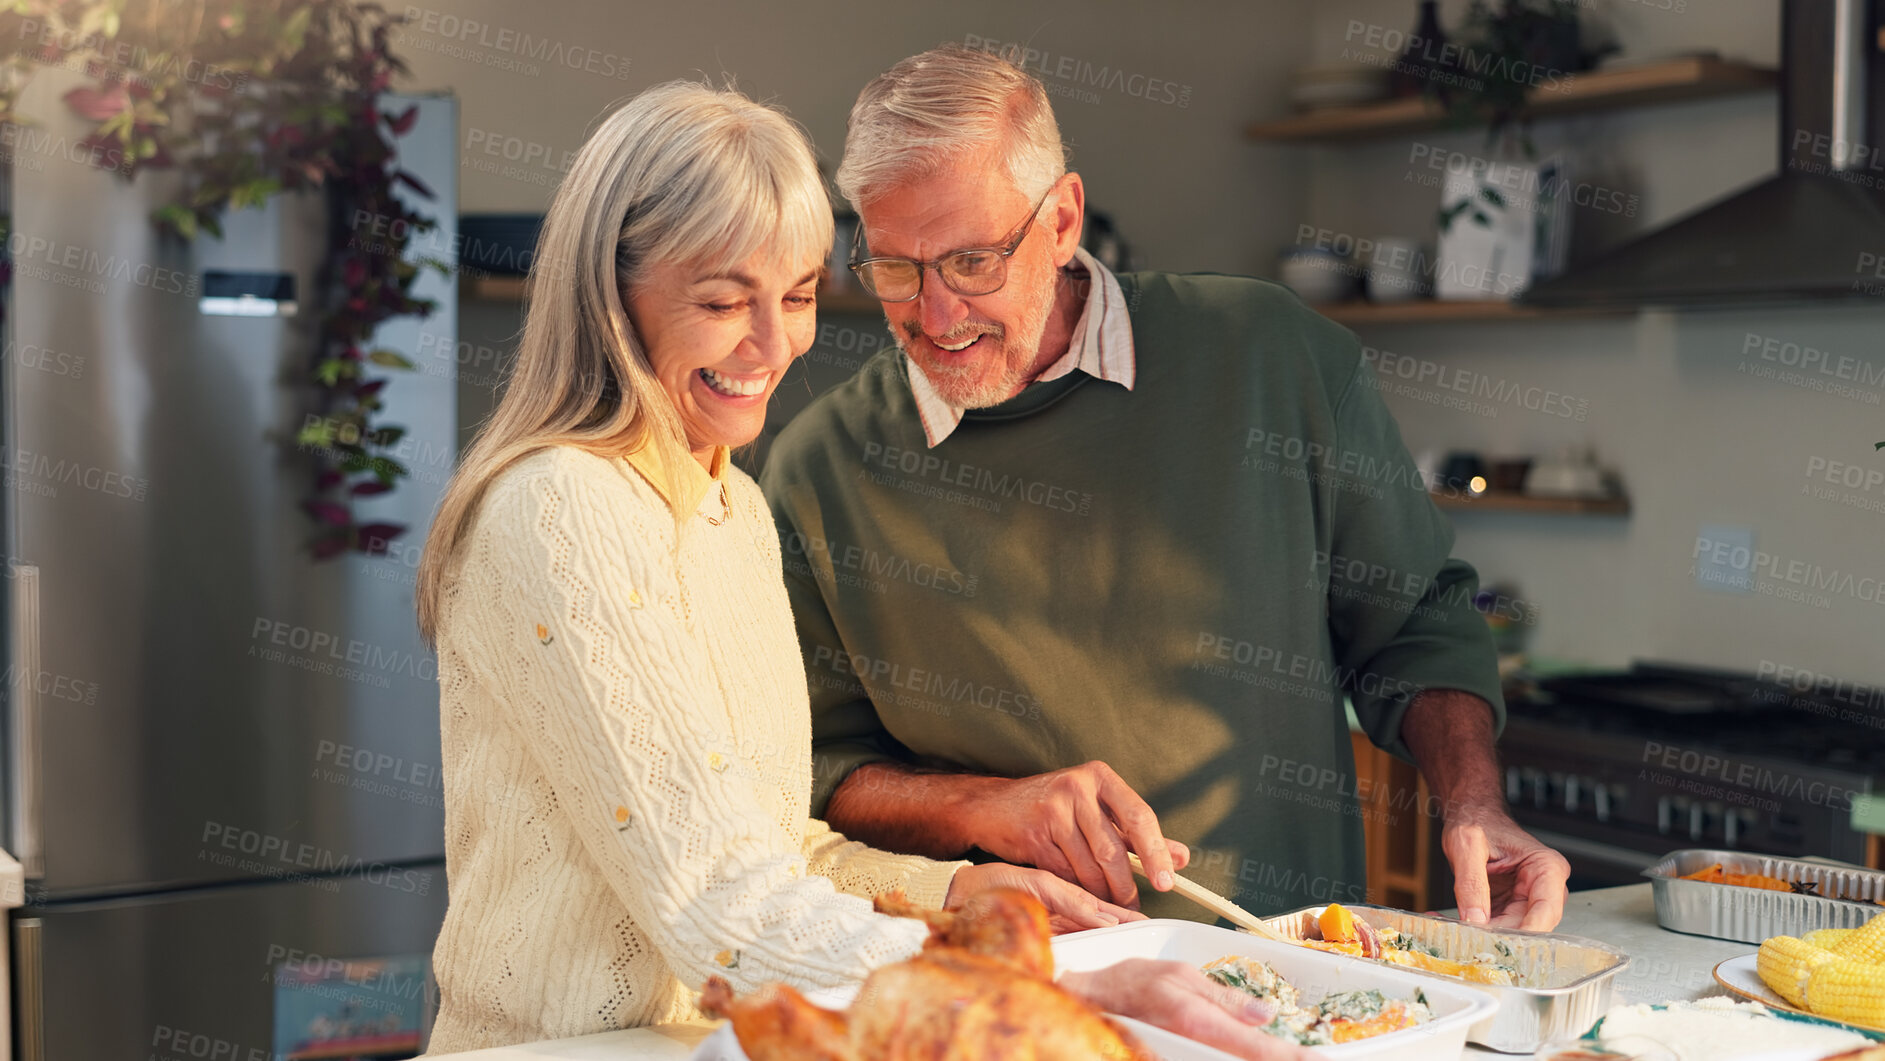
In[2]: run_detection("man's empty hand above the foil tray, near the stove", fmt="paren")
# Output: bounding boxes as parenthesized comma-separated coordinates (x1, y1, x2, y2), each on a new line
(1440, 808, 1570, 933)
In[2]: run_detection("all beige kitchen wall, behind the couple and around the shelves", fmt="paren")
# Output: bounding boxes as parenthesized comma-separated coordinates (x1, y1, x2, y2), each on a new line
(403, 0, 1885, 682)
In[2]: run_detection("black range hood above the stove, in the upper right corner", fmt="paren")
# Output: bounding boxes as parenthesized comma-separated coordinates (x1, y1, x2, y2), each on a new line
(1519, 0, 1885, 307)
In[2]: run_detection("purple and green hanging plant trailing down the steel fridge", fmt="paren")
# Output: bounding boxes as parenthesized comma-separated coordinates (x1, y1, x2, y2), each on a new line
(0, 0, 449, 560)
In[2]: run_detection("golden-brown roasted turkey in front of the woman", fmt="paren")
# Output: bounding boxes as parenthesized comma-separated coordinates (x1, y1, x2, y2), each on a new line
(701, 890, 1156, 1061)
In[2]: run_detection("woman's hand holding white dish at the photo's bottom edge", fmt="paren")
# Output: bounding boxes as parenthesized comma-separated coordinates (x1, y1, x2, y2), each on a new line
(1059, 957, 1316, 1061)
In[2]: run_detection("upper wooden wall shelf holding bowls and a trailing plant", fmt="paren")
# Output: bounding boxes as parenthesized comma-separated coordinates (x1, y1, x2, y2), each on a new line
(1244, 57, 1779, 143)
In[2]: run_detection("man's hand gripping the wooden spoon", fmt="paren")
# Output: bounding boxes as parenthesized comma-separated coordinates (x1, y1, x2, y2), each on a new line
(965, 759, 1191, 910)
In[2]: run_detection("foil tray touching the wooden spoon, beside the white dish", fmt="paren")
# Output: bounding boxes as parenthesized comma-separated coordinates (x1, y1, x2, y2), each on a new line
(1267, 903, 1631, 1053)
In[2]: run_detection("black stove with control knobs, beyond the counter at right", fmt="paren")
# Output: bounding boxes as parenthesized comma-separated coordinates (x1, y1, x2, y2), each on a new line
(1499, 665, 1885, 886)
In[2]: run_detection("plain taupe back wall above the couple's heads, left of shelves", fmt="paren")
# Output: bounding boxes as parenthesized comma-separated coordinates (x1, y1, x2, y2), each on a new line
(390, 0, 1310, 271)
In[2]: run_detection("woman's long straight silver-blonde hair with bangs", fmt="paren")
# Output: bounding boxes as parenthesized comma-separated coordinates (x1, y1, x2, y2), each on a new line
(415, 81, 831, 645)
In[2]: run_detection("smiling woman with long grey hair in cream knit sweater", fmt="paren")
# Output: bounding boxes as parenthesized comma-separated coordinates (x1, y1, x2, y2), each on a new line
(407, 83, 1304, 1053)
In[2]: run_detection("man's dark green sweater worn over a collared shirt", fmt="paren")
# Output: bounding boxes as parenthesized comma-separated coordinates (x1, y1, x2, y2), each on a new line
(762, 273, 1504, 918)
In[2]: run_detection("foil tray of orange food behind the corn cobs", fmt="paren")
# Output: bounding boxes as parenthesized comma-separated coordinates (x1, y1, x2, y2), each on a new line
(1644, 848, 1885, 944)
